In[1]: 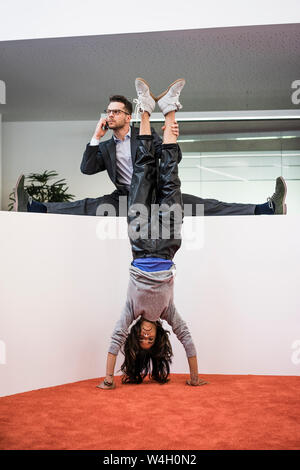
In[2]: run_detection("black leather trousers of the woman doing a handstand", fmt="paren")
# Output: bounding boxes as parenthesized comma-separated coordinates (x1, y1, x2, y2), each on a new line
(127, 135, 183, 259)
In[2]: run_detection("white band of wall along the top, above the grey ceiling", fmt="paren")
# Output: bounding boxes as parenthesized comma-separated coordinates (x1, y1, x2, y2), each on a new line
(0, 0, 300, 41)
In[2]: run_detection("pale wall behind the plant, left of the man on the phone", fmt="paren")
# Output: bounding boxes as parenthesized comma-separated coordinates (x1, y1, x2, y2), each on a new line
(2, 121, 115, 210)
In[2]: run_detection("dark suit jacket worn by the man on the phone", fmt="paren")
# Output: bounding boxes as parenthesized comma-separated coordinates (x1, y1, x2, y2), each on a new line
(80, 126, 181, 190)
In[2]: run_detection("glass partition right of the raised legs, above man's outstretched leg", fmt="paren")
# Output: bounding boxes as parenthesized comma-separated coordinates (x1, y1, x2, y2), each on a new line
(152, 113, 300, 214)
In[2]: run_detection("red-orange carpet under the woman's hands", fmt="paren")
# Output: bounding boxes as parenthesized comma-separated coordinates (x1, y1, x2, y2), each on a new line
(0, 374, 300, 450)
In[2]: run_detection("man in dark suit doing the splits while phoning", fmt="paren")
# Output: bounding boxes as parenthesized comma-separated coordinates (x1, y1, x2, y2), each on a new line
(14, 95, 287, 216)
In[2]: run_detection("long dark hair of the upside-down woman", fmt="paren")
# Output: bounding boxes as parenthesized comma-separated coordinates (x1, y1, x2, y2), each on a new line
(121, 318, 173, 384)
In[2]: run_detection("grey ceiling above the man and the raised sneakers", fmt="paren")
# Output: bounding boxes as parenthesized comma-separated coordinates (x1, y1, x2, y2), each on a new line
(0, 24, 300, 128)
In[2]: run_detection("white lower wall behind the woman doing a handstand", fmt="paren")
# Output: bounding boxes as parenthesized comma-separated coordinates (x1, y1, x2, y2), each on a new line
(0, 212, 300, 395)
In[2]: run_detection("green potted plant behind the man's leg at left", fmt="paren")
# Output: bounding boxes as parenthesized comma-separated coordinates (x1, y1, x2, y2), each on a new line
(8, 170, 75, 211)
